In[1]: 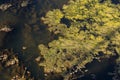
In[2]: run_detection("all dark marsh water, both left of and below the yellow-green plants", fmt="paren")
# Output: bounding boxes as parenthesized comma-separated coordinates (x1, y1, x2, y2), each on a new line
(0, 0, 119, 80)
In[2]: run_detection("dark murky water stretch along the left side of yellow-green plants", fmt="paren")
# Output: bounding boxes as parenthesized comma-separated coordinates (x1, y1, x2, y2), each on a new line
(1, 0, 67, 80)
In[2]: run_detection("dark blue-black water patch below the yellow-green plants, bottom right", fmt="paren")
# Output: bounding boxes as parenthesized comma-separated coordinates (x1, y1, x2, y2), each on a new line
(81, 57, 116, 80)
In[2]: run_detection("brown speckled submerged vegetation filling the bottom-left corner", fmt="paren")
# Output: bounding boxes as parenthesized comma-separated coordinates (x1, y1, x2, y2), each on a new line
(0, 49, 34, 80)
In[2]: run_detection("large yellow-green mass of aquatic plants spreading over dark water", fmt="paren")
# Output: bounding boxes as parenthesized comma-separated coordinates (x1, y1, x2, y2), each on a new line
(39, 0, 120, 80)
